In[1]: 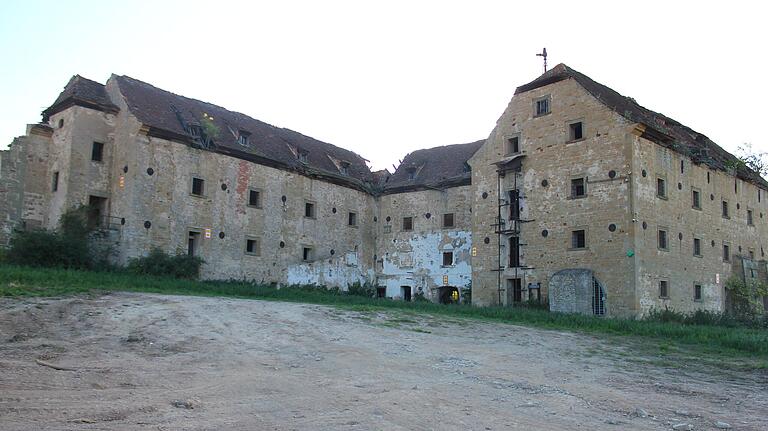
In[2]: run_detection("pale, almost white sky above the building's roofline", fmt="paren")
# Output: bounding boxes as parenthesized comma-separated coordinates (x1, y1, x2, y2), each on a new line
(0, 0, 768, 170)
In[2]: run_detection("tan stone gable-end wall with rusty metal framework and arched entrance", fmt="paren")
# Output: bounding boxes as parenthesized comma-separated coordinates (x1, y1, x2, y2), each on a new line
(470, 80, 635, 314)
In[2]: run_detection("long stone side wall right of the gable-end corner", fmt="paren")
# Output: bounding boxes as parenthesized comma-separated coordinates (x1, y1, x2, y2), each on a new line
(632, 137, 768, 313)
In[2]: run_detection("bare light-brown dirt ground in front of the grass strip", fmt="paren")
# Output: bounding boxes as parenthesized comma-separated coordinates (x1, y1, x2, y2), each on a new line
(0, 293, 768, 430)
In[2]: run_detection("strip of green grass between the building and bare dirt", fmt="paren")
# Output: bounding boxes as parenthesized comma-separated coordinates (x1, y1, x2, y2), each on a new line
(0, 265, 768, 364)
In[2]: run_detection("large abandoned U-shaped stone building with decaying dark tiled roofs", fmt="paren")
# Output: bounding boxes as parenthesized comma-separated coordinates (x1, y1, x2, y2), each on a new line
(0, 64, 768, 315)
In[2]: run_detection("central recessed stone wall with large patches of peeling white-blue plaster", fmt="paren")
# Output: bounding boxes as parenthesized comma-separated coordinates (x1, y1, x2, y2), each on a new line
(376, 186, 472, 301)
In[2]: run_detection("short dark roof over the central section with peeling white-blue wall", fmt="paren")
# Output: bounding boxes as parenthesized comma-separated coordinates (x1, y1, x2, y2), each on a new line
(384, 139, 485, 194)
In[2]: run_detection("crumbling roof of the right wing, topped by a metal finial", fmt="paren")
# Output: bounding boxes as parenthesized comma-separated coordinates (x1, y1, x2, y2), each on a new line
(515, 63, 768, 189)
